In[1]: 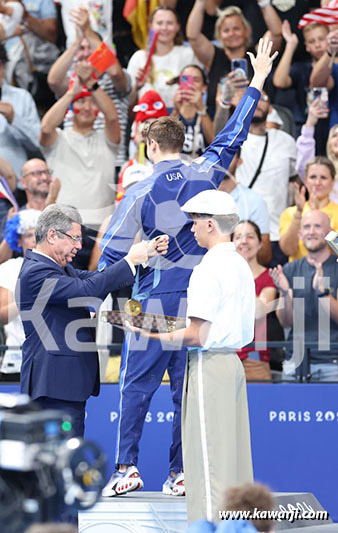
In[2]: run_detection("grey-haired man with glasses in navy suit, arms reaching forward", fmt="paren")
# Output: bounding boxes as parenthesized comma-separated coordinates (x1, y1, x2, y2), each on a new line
(16, 204, 168, 436)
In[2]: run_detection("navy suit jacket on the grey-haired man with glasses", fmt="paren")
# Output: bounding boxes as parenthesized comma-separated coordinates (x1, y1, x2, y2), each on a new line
(15, 250, 134, 401)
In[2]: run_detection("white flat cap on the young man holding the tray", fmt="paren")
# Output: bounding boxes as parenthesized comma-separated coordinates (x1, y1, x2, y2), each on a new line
(181, 189, 238, 215)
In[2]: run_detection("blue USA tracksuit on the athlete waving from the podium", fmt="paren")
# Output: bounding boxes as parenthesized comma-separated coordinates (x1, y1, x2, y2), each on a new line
(99, 87, 260, 496)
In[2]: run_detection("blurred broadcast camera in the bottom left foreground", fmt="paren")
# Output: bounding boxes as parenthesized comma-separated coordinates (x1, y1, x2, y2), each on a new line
(0, 394, 105, 533)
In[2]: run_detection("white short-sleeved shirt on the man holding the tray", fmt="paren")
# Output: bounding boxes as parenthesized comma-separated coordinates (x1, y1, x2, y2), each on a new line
(187, 242, 256, 350)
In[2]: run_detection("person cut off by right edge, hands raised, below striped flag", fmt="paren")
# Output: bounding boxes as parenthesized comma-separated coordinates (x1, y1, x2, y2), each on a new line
(310, 30, 338, 128)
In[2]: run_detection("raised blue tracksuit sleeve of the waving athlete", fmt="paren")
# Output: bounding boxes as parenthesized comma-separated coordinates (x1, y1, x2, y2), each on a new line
(193, 87, 261, 187)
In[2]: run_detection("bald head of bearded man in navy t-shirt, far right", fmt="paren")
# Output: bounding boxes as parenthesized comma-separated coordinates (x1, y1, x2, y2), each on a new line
(300, 209, 331, 252)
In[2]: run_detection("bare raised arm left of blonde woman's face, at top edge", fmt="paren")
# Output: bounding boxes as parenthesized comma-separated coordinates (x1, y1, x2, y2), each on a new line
(186, 0, 215, 71)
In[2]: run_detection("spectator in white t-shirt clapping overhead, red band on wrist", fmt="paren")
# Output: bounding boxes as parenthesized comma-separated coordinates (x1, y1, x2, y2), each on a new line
(40, 68, 120, 264)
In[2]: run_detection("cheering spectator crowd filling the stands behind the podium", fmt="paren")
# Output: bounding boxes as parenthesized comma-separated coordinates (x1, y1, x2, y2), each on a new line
(0, 0, 338, 381)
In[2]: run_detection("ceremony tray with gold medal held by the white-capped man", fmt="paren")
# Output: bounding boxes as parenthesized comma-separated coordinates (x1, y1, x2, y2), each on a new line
(100, 300, 186, 333)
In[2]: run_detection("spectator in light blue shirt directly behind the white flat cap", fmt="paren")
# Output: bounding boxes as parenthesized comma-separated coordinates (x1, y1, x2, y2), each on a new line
(218, 151, 271, 265)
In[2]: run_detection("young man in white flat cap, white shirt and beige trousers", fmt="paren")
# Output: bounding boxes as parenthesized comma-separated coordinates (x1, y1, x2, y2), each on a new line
(130, 190, 255, 522)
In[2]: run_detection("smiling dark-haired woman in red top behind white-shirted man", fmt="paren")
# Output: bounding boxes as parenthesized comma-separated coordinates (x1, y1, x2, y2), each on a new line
(232, 220, 277, 380)
